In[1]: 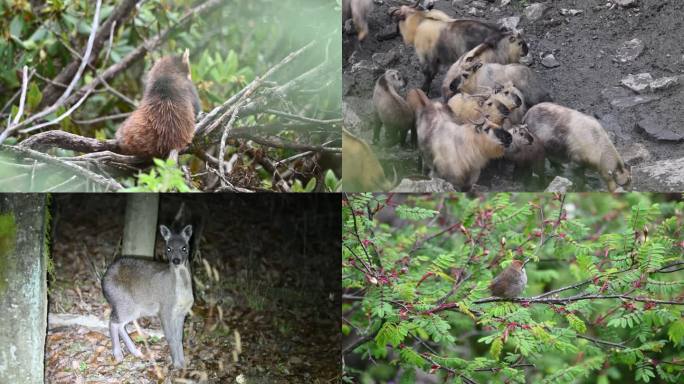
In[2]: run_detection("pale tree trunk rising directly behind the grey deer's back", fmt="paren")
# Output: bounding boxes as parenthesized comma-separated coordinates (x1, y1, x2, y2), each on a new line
(121, 193, 159, 258)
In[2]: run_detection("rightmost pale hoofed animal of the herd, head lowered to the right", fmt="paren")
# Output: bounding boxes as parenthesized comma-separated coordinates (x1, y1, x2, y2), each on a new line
(524, 103, 632, 192)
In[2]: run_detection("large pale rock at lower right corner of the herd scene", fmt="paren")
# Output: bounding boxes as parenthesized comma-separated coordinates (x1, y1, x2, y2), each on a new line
(632, 157, 684, 192)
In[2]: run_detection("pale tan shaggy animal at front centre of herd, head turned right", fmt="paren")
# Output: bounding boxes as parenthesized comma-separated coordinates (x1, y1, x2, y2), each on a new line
(407, 89, 511, 191)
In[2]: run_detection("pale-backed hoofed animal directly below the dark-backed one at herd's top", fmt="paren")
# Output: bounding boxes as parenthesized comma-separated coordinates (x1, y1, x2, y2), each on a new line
(450, 62, 551, 108)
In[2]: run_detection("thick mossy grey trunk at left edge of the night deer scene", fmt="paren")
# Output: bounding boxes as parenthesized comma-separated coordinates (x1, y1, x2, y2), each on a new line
(0, 194, 49, 383)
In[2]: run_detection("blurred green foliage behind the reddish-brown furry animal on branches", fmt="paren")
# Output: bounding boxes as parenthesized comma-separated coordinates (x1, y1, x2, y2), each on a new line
(0, 0, 341, 191)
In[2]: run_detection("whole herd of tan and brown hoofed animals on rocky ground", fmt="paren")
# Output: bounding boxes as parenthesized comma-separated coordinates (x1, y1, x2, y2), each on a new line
(342, 0, 631, 192)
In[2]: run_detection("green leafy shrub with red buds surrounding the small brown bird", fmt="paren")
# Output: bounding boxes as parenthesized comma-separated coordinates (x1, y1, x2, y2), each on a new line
(342, 193, 684, 384)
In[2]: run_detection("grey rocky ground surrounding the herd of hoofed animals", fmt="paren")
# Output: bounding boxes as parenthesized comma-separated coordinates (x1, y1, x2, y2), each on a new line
(343, 0, 684, 191)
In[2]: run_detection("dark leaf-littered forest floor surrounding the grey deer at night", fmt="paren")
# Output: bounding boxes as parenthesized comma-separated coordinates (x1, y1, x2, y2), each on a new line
(45, 195, 341, 383)
